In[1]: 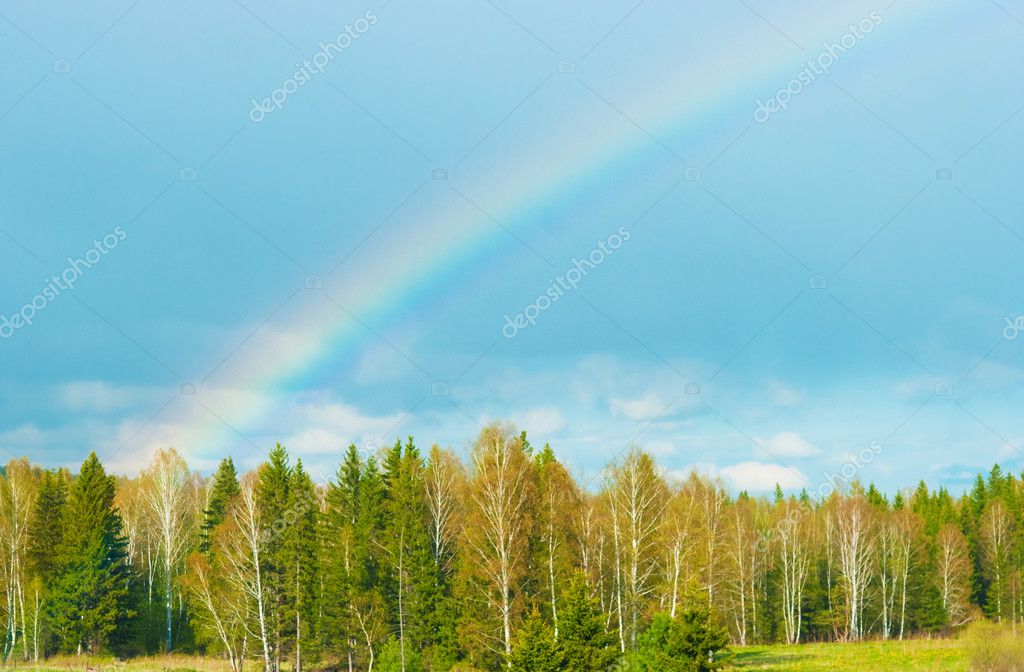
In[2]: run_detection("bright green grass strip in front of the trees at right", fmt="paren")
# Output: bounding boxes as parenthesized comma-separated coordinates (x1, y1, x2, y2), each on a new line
(731, 639, 969, 672)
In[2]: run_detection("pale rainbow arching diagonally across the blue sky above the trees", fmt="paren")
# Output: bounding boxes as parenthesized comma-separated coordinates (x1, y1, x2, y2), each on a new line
(182, 0, 963, 455)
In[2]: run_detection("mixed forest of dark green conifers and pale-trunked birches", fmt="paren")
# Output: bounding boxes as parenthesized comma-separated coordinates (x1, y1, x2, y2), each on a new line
(0, 423, 1024, 672)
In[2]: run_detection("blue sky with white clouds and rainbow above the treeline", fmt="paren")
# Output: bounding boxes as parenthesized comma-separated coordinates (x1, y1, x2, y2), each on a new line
(0, 0, 1024, 493)
